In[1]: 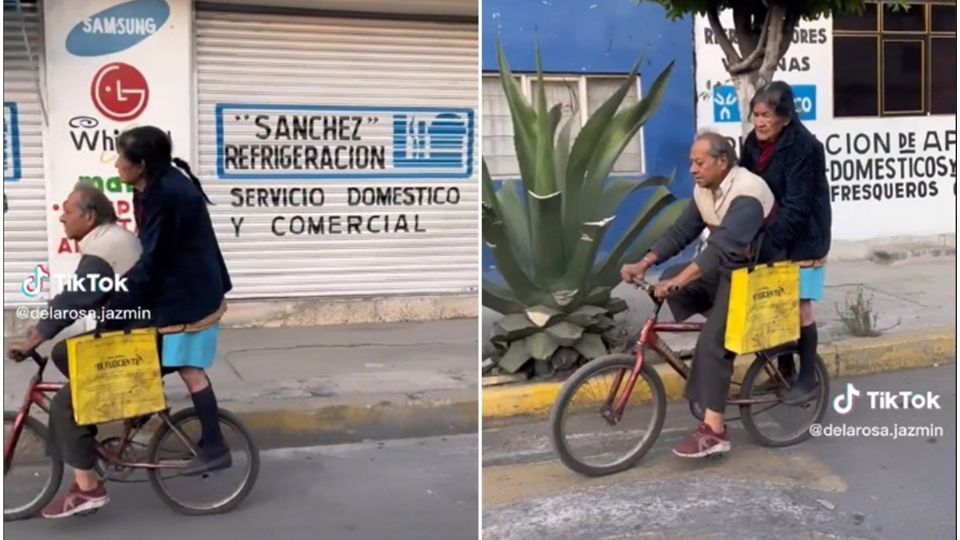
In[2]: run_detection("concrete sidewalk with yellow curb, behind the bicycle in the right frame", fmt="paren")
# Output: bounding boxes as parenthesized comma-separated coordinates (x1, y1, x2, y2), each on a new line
(483, 254, 957, 419)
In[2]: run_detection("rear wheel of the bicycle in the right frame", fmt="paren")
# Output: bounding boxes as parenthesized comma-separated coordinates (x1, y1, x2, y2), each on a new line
(740, 351, 830, 447)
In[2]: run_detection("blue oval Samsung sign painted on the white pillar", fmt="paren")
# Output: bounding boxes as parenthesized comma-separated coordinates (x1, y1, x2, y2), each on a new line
(67, 0, 170, 56)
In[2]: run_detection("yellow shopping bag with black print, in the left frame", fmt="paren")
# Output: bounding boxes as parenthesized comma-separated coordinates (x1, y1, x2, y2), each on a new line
(67, 328, 166, 426)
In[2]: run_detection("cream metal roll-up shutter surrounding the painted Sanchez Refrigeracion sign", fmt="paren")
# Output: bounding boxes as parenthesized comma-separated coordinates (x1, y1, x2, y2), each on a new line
(195, 10, 479, 298)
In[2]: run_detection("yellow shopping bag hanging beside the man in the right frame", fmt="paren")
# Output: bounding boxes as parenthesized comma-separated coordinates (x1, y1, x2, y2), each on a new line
(724, 262, 800, 354)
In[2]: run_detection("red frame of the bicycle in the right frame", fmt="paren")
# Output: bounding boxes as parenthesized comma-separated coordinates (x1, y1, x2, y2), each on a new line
(603, 283, 789, 422)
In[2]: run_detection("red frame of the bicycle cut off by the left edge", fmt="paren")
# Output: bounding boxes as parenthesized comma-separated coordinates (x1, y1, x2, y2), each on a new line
(3, 353, 189, 475)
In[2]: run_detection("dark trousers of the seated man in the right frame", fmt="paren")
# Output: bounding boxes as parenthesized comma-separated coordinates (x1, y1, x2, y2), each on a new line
(661, 264, 736, 414)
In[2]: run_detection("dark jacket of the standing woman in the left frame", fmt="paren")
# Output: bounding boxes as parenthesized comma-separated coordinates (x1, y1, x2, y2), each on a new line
(111, 166, 233, 327)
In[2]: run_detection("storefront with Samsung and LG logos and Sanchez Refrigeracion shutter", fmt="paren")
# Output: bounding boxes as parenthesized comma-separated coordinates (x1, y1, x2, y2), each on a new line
(5, 0, 479, 305)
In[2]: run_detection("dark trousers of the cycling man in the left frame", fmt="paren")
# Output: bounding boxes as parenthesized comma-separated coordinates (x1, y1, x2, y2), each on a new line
(48, 332, 177, 470)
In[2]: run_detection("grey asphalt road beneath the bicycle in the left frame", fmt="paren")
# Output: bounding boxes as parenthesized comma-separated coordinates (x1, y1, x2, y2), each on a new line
(4, 435, 478, 540)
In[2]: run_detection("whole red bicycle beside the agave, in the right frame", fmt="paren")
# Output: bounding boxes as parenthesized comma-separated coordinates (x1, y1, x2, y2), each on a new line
(550, 282, 830, 476)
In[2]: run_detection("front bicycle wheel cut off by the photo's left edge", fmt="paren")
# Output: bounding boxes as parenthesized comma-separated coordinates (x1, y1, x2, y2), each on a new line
(3, 411, 63, 521)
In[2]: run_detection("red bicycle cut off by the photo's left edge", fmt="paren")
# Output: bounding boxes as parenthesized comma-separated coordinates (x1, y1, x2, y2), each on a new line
(3, 352, 260, 521)
